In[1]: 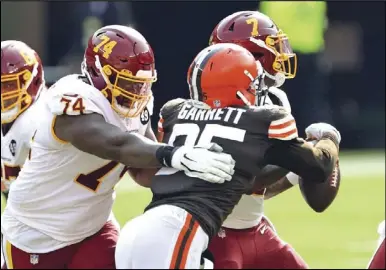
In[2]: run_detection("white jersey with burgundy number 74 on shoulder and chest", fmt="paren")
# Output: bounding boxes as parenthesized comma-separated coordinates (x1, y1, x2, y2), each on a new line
(1, 75, 152, 253)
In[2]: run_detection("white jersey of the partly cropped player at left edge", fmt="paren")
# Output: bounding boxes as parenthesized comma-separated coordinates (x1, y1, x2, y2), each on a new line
(1, 88, 46, 190)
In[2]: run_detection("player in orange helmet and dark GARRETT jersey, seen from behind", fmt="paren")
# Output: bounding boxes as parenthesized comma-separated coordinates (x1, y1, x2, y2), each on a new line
(115, 43, 340, 269)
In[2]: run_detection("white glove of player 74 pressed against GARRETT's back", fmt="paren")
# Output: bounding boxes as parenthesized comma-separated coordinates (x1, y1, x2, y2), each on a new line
(171, 143, 235, 184)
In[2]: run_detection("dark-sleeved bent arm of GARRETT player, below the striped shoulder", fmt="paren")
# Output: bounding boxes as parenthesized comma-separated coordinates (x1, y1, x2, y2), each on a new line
(267, 139, 338, 182)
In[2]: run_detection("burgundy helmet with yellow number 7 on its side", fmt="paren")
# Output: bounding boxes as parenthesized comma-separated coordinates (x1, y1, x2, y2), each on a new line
(209, 11, 297, 86)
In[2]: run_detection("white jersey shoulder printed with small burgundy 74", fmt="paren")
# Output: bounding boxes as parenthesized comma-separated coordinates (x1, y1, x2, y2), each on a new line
(46, 75, 109, 115)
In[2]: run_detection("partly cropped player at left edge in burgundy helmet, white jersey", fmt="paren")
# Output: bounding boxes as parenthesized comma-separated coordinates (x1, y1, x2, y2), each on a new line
(1, 40, 45, 198)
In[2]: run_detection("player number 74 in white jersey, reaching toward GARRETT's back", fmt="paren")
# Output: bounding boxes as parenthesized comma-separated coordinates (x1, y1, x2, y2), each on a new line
(1, 25, 234, 269)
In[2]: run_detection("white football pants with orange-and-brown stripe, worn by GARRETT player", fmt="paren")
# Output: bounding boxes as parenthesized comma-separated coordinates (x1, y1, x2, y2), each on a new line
(115, 205, 209, 269)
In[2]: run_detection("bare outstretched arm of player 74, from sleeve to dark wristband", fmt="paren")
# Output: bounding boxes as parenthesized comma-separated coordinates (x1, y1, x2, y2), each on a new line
(55, 114, 173, 168)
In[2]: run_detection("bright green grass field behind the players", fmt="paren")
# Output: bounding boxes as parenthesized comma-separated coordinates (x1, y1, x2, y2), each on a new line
(2, 152, 385, 269)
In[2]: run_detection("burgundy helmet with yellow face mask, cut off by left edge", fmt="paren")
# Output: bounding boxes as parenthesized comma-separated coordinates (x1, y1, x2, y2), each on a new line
(1, 40, 45, 124)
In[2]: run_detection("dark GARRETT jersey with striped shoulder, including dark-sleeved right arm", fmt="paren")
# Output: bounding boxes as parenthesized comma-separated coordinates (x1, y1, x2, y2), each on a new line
(148, 99, 337, 237)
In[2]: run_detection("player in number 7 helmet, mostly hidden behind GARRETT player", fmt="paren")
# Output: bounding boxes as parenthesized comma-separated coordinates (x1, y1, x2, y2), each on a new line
(205, 11, 311, 269)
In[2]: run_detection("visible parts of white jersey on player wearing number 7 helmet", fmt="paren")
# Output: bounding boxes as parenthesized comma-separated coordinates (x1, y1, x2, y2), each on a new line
(222, 87, 296, 229)
